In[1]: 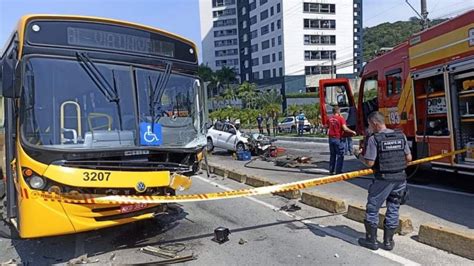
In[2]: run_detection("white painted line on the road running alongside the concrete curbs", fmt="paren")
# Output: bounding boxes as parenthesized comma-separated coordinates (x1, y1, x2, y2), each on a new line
(193, 175, 420, 265)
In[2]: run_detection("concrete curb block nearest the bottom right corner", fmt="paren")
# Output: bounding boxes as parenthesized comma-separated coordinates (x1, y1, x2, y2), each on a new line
(418, 223, 474, 260)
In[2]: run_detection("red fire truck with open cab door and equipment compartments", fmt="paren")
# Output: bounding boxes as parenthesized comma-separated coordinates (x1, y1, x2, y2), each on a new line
(319, 10, 474, 175)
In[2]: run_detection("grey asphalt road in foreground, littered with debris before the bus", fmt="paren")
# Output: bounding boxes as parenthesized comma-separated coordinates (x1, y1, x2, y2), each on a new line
(0, 176, 472, 265)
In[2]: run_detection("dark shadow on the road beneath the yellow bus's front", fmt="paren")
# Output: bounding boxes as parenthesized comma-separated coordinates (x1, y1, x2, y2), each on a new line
(6, 207, 188, 265)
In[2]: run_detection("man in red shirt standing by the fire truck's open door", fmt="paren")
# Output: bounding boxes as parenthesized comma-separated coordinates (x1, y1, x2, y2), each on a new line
(327, 106, 356, 174)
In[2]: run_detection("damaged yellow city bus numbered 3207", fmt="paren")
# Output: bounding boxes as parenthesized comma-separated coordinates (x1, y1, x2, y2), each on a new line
(0, 15, 207, 238)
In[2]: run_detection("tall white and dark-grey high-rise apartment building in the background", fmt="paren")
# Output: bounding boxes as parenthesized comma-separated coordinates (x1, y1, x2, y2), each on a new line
(199, 0, 362, 108)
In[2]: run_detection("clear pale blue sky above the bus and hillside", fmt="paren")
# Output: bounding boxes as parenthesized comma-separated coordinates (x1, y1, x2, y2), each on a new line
(0, 0, 474, 60)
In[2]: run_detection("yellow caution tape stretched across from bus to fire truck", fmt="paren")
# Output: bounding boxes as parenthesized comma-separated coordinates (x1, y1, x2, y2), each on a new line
(31, 149, 467, 204)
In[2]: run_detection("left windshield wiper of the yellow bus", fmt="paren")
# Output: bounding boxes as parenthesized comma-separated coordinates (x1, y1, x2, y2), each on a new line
(76, 52, 123, 131)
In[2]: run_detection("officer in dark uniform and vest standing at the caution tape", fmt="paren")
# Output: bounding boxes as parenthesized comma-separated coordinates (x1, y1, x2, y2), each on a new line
(355, 112, 412, 250)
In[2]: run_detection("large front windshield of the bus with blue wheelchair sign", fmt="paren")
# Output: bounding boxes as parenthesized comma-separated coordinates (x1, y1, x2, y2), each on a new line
(20, 57, 206, 150)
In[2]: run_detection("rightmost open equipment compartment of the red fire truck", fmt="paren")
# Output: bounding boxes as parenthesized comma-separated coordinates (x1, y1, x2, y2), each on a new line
(446, 59, 474, 170)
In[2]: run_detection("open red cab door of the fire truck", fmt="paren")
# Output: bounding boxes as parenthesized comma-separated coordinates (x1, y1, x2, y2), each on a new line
(319, 78, 357, 133)
